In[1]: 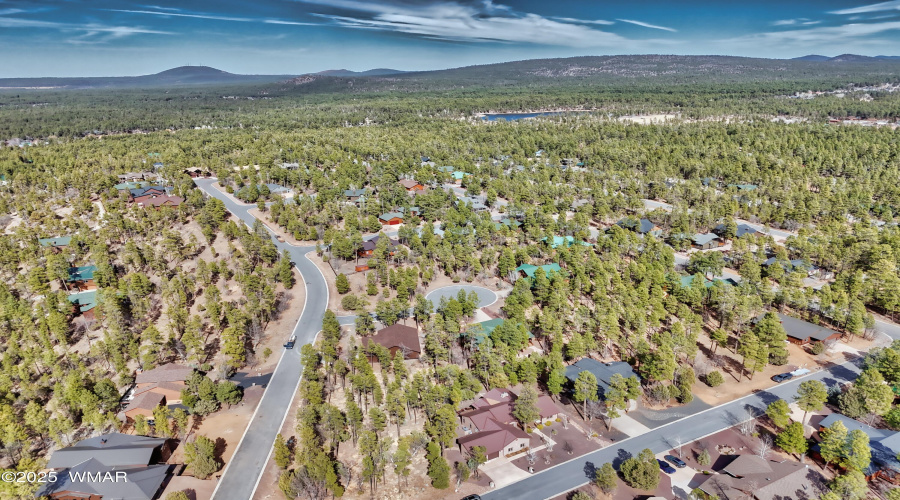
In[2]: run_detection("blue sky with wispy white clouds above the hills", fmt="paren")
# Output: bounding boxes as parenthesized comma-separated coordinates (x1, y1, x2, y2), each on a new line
(0, 0, 900, 77)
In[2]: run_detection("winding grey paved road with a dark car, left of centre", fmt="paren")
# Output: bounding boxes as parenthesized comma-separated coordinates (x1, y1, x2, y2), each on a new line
(195, 179, 328, 500)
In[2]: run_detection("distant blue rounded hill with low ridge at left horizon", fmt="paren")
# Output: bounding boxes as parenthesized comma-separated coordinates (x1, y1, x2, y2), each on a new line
(0, 66, 294, 89)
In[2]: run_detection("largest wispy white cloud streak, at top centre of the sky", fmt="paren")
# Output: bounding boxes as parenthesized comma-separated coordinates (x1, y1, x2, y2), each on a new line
(299, 0, 628, 47)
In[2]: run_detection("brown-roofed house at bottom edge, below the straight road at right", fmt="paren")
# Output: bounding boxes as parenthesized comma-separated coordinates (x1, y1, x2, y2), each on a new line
(698, 455, 825, 500)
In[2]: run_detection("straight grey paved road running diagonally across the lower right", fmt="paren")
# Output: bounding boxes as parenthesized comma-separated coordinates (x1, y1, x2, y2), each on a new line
(481, 360, 861, 500)
